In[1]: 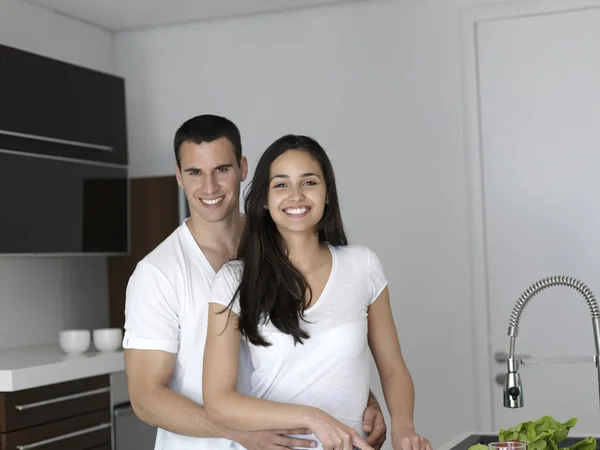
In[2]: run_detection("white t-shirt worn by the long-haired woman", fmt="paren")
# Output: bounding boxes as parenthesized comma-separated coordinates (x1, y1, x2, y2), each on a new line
(210, 245, 387, 448)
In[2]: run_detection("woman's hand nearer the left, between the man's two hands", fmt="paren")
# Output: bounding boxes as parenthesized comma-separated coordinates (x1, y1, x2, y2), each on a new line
(309, 410, 373, 450)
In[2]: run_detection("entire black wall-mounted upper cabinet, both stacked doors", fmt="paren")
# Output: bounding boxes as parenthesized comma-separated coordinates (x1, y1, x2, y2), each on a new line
(0, 45, 129, 254)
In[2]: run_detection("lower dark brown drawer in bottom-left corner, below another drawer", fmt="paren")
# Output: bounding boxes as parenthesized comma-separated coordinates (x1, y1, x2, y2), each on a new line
(0, 409, 111, 450)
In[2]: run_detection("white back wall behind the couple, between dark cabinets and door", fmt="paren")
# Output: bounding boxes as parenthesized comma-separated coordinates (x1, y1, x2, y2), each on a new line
(116, 0, 484, 448)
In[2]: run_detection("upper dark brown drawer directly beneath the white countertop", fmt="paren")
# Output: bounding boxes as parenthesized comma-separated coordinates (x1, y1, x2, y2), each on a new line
(0, 375, 110, 432)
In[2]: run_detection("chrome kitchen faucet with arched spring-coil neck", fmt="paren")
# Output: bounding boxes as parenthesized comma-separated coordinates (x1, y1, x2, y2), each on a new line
(504, 276, 600, 408)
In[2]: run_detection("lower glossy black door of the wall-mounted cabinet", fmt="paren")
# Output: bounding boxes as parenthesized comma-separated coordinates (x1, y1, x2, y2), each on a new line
(0, 149, 129, 254)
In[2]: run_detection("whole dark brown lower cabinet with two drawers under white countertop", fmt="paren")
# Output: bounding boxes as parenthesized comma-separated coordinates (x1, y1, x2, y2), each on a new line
(0, 376, 112, 450)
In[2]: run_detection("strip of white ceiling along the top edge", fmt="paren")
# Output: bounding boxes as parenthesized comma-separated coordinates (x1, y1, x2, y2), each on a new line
(26, 0, 366, 31)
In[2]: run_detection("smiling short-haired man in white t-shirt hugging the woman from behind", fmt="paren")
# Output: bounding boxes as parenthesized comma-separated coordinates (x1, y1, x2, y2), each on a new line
(123, 115, 386, 450)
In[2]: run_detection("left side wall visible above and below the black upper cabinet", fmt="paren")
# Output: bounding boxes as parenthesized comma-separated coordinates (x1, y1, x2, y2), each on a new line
(0, 0, 115, 350)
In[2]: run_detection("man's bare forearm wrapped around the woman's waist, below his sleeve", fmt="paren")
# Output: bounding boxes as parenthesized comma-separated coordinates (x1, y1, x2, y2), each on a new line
(132, 386, 239, 440)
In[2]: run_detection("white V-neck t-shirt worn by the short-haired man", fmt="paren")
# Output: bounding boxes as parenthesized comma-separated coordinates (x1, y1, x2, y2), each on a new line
(123, 222, 252, 450)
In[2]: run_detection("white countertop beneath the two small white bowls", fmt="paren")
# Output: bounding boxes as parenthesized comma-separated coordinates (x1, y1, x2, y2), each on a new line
(0, 344, 125, 392)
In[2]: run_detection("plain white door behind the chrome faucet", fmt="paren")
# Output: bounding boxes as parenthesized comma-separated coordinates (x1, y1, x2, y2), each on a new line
(476, 2, 600, 437)
